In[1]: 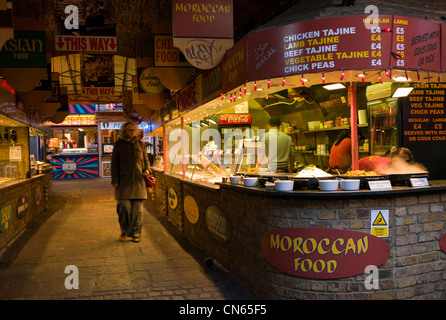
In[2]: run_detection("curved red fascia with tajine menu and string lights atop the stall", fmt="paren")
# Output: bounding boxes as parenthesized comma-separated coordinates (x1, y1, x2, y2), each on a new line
(221, 15, 446, 92)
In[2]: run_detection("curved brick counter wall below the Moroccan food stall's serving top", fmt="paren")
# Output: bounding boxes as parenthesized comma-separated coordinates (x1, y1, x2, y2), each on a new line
(151, 175, 446, 300)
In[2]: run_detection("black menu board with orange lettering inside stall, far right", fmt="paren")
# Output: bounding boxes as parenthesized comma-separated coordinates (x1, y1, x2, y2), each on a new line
(401, 82, 446, 179)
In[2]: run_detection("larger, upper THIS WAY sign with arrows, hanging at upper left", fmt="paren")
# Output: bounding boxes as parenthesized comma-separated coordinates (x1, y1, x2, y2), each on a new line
(56, 35, 117, 53)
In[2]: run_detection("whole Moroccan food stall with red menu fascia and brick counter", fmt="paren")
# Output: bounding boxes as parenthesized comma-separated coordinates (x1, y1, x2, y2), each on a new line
(150, 15, 446, 299)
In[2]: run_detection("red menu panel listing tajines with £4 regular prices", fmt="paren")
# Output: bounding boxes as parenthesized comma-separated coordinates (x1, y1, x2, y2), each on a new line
(248, 15, 392, 79)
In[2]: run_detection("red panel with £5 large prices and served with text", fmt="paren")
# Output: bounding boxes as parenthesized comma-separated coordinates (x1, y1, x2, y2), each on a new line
(392, 16, 441, 71)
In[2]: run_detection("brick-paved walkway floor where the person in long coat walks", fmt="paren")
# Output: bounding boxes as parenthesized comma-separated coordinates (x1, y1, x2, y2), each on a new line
(0, 179, 254, 300)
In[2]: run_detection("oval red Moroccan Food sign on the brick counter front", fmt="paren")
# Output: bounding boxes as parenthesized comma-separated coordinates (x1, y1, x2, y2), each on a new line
(262, 228, 390, 279)
